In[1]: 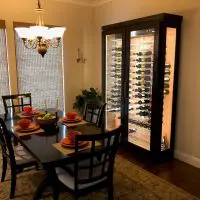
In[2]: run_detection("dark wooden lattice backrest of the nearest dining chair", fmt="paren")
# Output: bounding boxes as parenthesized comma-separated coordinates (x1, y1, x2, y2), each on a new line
(74, 126, 122, 190)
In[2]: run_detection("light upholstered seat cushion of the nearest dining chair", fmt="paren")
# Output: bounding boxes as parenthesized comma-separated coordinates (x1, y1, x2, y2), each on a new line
(56, 159, 107, 190)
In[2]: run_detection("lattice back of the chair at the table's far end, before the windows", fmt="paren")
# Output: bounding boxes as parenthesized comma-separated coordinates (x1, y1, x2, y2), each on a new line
(2, 93, 32, 114)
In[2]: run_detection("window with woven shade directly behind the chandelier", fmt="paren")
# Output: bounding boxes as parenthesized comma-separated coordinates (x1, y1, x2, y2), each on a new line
(15, 23, 64, 110)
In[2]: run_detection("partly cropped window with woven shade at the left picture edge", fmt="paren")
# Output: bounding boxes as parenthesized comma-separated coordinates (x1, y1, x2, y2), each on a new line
(0, 20, 10, 114)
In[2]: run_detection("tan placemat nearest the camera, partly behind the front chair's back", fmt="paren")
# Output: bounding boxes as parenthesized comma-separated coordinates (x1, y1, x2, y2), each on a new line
(52, 142, 101, 155)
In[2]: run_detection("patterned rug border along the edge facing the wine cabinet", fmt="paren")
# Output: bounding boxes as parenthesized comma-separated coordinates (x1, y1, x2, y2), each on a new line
(115, 155, 200, 200)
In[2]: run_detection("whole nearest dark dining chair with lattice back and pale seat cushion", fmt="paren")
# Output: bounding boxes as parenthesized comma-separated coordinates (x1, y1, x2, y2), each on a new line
(54, 126, 122, 200)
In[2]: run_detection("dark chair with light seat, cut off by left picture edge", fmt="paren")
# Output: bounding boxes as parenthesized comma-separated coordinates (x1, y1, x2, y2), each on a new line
(0, 118, 38, 198)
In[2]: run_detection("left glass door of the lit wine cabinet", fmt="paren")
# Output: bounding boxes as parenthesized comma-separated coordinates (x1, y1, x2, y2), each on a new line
(105, 34, 122, 130)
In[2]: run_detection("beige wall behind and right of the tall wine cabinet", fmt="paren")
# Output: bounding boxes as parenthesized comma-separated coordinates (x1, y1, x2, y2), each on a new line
(92, 0, 200, 167)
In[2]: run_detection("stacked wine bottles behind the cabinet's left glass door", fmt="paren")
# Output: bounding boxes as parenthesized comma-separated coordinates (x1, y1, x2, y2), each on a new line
(106, 38, 122, 111)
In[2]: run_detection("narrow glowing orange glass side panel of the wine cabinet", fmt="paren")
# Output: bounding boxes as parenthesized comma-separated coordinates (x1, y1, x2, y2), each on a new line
(161, 28, 176, 151)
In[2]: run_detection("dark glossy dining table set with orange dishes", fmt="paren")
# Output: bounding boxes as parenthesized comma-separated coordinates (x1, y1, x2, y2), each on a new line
(0, 109, 102, 200)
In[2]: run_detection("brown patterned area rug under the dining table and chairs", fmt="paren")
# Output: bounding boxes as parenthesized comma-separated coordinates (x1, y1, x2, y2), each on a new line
(0, 150, 200, 200)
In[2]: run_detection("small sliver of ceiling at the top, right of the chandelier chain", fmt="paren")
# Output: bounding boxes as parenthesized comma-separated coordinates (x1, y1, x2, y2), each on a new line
(56, 0, 112, 6)
